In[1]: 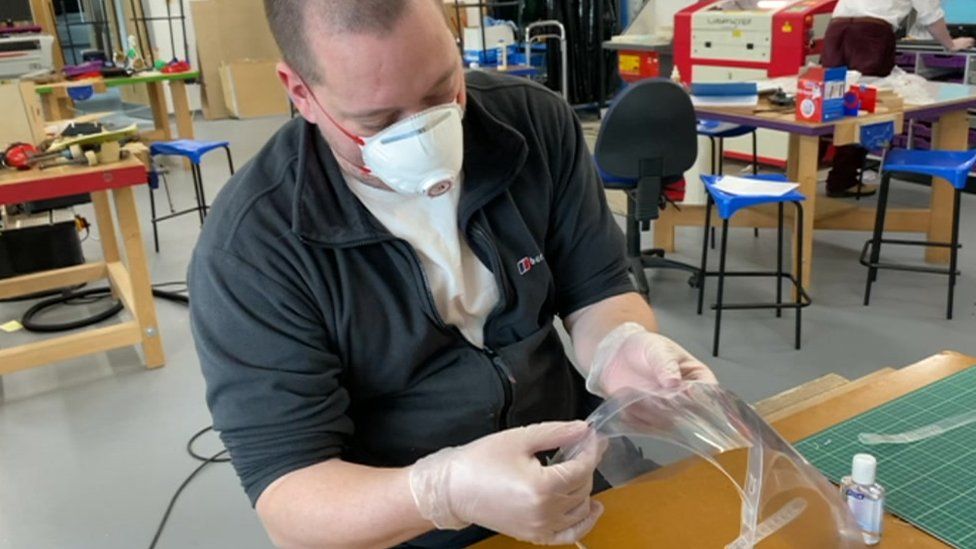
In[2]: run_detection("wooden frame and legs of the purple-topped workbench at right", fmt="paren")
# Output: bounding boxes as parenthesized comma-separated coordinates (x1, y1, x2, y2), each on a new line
(654, 82, 976, 289)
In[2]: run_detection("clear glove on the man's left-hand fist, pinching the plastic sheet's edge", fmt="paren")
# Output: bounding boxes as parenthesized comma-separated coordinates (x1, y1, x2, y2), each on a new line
(410, 421, 606, 545)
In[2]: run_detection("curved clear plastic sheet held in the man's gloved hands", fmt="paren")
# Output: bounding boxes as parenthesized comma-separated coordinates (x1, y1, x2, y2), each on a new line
(553, 383, 863, 549)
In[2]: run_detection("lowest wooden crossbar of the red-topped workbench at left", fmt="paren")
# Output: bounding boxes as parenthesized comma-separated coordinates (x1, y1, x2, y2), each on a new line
(0, 321, 140, 375)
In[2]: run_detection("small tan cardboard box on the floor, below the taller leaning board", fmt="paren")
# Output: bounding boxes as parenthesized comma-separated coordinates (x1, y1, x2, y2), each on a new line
(220, 59, 290, 118)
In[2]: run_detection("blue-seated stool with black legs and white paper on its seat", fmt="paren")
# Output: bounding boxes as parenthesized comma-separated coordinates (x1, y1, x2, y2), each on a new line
(698, 175, 811, 356)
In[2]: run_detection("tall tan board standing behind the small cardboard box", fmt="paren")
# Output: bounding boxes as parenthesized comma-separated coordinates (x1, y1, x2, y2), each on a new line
(190, 0, 281, 120)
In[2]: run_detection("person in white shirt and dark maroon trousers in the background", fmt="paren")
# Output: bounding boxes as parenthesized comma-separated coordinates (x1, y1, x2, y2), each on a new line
(821, 0, 973, 198)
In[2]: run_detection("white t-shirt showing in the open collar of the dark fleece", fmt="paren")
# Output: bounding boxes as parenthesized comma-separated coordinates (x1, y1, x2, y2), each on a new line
(346, 176, 499, 348)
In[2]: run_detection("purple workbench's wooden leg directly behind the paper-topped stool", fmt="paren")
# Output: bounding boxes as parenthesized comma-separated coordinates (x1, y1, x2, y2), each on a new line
(787, 135, 820, 292)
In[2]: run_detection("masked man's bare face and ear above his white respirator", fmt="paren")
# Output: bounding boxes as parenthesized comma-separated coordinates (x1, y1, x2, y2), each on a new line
(278, 0, 466, 185)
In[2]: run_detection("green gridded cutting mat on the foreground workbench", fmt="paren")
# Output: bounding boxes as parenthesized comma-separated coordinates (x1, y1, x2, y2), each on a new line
(796, 367, 976, 549)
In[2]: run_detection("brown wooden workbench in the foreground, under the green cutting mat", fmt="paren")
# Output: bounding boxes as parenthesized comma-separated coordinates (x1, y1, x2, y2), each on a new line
(476, 352, 976, 549)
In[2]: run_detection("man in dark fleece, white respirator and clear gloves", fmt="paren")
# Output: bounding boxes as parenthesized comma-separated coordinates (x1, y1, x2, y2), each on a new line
(190, 0, 715, 547)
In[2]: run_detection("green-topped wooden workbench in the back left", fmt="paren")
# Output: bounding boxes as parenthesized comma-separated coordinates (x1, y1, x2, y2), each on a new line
(34, 71, 200, 142)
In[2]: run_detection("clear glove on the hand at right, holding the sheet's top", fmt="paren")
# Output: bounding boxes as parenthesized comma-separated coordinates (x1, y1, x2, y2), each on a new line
(586, 322, 718, 398)
